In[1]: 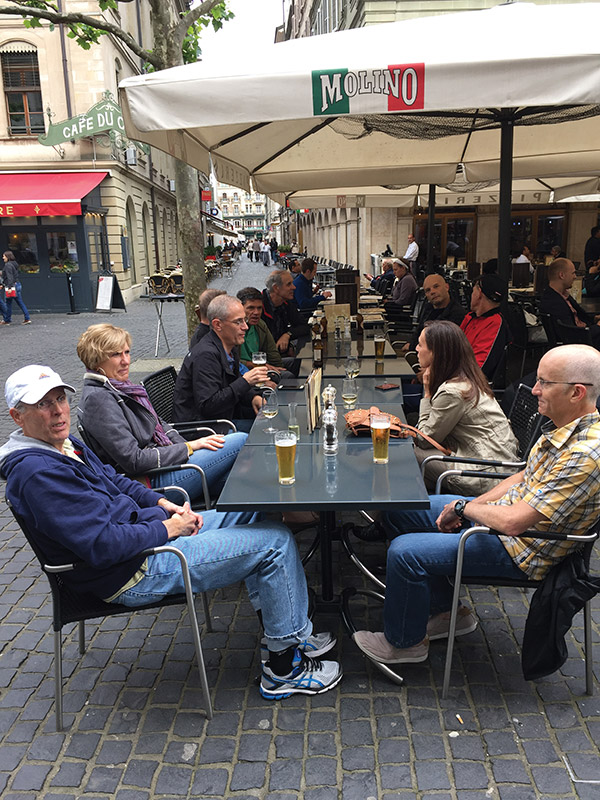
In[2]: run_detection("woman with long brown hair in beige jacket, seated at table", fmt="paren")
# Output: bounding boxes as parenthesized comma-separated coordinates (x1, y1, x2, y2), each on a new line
(415, 321, 517, 495)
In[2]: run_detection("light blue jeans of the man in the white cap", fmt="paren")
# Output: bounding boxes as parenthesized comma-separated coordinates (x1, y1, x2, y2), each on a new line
(113, 511, 312, 651)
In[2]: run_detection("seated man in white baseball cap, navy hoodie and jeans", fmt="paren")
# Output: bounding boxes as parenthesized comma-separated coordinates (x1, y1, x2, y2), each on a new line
(0, 362, 342, 699)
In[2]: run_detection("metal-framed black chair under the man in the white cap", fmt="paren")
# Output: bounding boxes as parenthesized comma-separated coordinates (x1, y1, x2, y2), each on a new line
(7, 500, 213, 731)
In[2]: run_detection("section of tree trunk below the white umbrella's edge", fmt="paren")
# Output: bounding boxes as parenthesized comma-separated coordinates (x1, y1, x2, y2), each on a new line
(175, 161, 206, 336)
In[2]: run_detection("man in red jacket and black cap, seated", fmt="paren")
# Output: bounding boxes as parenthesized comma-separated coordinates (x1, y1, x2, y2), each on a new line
(460, 275, 511, 380)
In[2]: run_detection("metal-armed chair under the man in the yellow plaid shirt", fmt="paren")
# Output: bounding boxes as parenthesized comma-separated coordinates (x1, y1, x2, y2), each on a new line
(442, 520, 600, 699)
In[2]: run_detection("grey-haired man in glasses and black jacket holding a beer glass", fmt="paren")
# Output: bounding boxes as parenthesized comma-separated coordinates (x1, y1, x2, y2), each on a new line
(173, 294, 268, 431)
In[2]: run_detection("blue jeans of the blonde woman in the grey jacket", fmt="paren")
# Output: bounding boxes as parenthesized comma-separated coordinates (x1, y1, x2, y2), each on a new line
(150, 432, 248, 501)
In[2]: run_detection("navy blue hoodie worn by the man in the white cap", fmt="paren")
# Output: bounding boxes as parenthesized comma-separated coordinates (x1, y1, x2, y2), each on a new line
(0, 430, 168, 598)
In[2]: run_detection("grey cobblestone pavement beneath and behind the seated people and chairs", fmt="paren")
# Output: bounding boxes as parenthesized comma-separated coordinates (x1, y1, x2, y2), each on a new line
(0, 252, 600, 800)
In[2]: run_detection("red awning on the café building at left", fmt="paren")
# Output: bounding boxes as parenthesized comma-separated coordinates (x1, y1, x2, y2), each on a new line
(0, 172, 108, 219)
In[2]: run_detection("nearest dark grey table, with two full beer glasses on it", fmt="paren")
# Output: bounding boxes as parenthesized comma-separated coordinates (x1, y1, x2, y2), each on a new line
(217, 439, 429, 605)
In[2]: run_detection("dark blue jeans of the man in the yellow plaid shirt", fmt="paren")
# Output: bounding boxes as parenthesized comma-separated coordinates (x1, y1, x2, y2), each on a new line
(382, 494, 525, 648)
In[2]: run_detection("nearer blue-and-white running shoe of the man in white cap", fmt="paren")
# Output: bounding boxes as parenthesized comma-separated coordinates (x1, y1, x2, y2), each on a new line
(260, 648, 342, 700)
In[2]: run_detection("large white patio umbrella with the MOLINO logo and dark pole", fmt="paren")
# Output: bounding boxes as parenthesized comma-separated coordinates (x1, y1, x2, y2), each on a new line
(120, 3, 600, 270)
